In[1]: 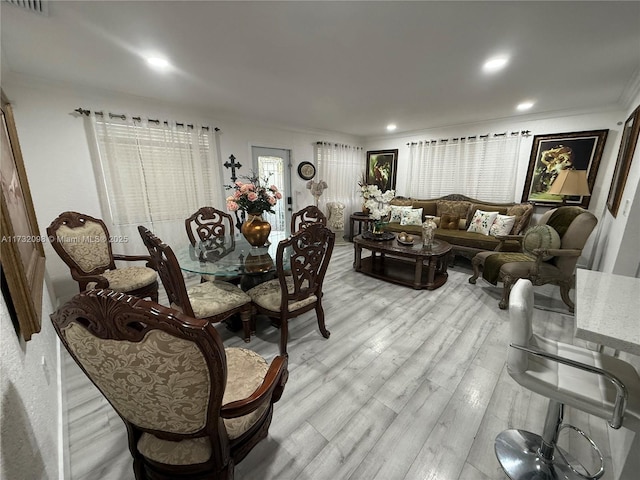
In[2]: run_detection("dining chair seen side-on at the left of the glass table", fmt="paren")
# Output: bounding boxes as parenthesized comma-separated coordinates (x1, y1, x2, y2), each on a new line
(138, 225, 251, 342)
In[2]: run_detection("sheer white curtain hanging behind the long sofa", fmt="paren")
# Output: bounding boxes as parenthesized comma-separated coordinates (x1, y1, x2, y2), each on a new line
(407, 132, 522, 202)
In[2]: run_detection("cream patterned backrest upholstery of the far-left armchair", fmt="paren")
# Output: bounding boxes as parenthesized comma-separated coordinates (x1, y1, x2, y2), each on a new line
(56, 222, 111, 273)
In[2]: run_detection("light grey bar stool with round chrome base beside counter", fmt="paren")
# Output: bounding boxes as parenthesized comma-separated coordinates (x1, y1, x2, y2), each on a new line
(495, 279, 640, 480)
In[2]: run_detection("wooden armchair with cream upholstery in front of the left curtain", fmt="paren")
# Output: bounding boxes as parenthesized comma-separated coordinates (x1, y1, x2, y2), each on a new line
(47, 212, 158, 302)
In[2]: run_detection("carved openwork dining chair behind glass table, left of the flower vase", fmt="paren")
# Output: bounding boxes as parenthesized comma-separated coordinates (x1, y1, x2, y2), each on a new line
(184, 207, 240, 285)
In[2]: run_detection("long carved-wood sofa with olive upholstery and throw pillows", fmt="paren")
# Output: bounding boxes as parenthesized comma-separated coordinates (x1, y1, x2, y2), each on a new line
(384, 194, 533, 260)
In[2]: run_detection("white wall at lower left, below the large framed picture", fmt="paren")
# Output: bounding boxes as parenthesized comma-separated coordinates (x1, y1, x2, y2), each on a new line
(0, 287, 60, 480)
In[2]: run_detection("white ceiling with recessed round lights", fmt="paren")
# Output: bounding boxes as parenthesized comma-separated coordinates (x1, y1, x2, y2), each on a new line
(0, 1, 640, 136)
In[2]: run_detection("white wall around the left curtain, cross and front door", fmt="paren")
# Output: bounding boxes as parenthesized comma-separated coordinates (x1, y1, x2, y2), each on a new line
(2, 76, 362, 306)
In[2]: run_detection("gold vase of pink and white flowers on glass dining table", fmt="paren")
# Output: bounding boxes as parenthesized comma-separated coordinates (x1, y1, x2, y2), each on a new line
(227, 174, 282, 247)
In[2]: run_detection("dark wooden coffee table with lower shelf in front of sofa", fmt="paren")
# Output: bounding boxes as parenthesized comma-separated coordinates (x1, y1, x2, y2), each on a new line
(353, 235, 451, 290)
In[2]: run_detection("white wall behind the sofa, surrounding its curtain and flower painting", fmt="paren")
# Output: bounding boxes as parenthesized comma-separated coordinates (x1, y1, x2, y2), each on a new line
(365, 109, 628, 268)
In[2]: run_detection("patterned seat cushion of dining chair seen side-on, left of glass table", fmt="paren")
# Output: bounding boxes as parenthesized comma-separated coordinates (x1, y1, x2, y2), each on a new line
(171, 281, 251, 318)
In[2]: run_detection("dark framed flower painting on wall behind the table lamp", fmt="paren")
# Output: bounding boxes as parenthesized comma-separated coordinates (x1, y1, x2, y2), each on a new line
(522, 130, 609, 208)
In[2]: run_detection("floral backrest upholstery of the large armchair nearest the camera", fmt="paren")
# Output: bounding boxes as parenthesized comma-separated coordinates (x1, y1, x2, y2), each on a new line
(63, 323, 211, 433)
